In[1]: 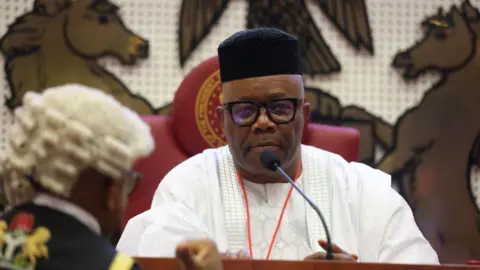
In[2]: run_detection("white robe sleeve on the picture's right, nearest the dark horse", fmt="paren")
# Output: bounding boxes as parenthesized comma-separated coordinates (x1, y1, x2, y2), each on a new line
(348, 163, 439, 264)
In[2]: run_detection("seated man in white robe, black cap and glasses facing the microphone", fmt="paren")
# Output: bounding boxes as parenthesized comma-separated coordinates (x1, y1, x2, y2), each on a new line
(117, 28, 438, 264)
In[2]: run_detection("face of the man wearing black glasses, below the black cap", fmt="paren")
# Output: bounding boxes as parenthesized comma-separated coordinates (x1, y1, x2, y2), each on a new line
(218, 75, 310, 175)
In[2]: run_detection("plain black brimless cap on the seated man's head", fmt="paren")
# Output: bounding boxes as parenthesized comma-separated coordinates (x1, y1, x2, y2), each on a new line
(218, 28, 302, 82)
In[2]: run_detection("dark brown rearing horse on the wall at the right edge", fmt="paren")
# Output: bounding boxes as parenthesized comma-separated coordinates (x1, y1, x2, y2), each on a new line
(377, 1, 480, 262)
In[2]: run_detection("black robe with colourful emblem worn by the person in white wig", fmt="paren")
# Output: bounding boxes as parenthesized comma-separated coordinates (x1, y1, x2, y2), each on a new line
(0, 204, 140, 270)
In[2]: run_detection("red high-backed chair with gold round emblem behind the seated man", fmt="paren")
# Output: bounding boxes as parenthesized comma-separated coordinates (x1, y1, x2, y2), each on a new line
(124, 56, 360, 226)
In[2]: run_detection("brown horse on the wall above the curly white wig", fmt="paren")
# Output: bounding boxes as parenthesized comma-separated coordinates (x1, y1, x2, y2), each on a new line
(0, 0, 158, 114)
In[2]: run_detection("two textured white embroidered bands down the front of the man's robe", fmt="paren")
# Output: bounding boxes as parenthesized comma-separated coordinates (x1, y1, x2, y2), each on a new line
(217, 145, 332, 252)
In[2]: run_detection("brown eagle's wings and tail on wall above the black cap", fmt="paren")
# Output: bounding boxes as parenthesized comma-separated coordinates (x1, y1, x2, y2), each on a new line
(178, 0, 374, 75)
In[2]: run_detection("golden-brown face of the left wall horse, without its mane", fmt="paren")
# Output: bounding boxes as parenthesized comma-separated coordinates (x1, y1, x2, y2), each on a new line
(64, 0, 149, 64)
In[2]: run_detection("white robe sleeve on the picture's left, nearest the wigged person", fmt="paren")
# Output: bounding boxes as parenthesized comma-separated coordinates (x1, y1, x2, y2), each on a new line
(117, 154, 213, 257)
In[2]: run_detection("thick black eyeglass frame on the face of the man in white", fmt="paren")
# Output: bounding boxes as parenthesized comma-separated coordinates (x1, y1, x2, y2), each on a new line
(223, 98, 303, 127)
